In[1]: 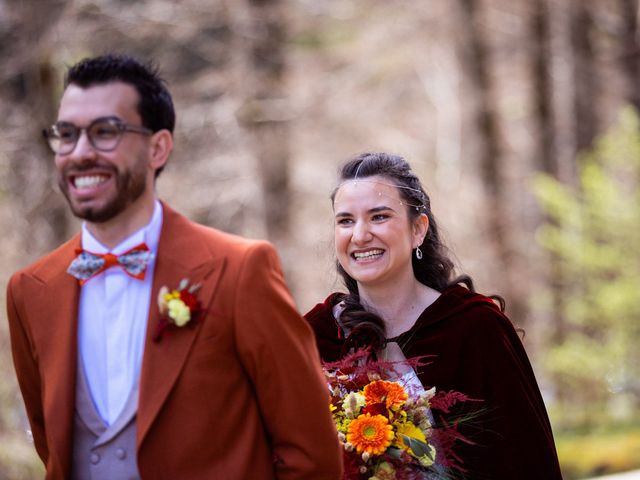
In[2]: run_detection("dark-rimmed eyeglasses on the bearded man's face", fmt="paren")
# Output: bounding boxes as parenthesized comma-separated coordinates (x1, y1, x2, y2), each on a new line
(42, 117, 153, 155)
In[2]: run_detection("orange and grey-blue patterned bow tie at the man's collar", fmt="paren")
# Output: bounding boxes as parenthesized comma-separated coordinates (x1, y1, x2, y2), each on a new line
(67, 243, 153, 285)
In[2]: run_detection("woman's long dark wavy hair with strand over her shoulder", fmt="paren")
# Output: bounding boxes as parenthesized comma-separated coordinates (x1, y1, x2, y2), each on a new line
(331, 153, 473, 351)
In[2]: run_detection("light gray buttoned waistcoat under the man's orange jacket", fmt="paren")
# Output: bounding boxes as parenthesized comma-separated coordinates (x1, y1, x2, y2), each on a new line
(71, 358, 140, 480)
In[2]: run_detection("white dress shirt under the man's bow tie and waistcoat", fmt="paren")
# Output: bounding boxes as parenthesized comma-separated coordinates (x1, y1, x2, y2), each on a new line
(78, 200, 162, 425)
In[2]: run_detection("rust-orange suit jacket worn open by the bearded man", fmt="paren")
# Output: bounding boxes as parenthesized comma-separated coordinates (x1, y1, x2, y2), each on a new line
(7, 204, 341, 480)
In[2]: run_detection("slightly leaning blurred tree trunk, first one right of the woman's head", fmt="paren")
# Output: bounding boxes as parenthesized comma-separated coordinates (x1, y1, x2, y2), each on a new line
(458, 0, 528, 325)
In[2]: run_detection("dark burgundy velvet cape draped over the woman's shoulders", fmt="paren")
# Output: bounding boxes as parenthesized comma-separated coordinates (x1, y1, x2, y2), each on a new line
(305, 286, 562, 480)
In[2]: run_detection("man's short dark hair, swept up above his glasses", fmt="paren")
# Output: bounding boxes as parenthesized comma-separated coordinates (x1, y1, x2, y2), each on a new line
(64, 54, 176, 176)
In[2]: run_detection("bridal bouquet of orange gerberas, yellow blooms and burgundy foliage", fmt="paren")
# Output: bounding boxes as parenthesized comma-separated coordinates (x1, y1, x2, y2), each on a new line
(324, 350, 470, 480)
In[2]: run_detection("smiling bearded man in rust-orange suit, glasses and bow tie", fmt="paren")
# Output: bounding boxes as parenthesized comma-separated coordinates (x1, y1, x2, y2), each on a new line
(7, 55, 341, 480)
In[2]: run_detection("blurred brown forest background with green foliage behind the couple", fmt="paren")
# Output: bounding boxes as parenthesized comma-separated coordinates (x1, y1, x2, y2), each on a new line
(0, 0, 640, 479)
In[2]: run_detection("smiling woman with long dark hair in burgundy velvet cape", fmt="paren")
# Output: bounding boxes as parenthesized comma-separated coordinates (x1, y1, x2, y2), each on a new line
(305, 153, 562, 480)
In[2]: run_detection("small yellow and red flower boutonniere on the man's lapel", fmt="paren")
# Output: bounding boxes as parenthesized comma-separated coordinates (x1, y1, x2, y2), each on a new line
(153, 278, 202, 342)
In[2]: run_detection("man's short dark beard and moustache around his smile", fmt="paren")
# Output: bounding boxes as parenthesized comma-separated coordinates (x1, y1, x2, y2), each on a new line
(58, 159, 147, 223)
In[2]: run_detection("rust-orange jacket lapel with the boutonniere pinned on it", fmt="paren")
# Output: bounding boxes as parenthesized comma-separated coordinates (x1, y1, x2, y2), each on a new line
(137, 203, 224, 448)
